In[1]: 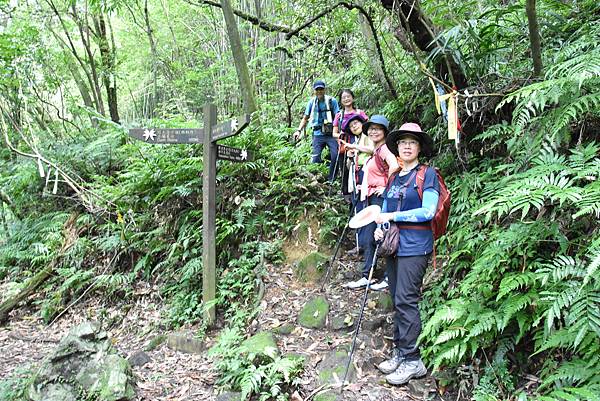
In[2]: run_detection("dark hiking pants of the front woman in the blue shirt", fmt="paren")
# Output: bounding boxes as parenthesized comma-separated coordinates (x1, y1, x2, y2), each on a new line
(386, 254, 431, 361)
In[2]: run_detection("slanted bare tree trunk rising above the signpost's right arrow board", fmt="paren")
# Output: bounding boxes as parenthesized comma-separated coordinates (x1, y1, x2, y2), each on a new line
(221, 0, 256, 113)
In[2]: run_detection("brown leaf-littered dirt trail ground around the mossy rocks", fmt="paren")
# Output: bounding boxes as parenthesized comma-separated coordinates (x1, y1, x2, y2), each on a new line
(0, 250, 440, 401)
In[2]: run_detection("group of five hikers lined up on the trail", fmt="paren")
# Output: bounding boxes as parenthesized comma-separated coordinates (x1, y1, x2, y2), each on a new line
(294, 80, 450, 385)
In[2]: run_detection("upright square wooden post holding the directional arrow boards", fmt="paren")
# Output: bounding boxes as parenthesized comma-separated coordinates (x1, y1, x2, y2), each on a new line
(202, 104, 217, 325)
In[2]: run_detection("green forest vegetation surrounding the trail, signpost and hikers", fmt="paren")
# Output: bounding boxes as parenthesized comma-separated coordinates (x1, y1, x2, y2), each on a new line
(0, 0, 600, 400)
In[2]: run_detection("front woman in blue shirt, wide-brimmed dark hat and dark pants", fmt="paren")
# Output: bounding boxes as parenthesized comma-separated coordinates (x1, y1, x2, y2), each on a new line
(375, 123, 439, 385)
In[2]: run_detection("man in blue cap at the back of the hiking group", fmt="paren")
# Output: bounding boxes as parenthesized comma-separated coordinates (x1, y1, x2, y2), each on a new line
(294, 79, 339, 181)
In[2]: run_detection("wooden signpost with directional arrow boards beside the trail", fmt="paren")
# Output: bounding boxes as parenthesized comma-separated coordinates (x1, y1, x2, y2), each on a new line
(129, 104, 252, 324)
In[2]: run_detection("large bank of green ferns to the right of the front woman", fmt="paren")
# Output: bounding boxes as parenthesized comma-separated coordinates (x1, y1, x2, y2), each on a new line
(421, 23, 600, 401)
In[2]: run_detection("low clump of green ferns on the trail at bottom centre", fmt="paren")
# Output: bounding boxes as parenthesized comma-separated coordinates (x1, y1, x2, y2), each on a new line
(209, 326, 304, 401)
